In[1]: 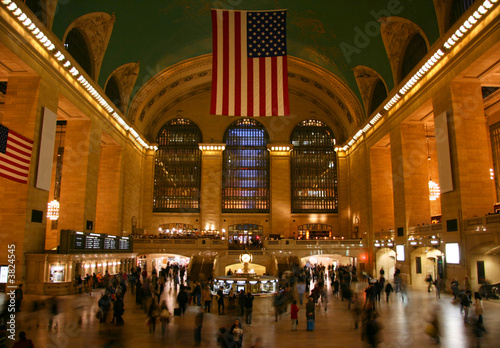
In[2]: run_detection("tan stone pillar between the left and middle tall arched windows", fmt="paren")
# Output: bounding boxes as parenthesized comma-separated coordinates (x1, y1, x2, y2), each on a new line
(199, 144, 226, 230)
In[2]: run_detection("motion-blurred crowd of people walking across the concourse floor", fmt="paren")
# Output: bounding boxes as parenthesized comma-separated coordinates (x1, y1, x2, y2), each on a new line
(1, 264, 486, 347)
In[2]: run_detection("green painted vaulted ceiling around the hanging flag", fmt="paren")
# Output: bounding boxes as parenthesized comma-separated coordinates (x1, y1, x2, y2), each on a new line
(53, 0, 439, 109)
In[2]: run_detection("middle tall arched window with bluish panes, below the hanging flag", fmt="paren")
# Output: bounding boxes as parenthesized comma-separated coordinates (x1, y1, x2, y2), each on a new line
(222, 118, 269, 213)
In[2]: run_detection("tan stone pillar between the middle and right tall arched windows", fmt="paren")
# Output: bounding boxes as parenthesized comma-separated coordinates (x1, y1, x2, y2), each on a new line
(267, 144, 293, 237)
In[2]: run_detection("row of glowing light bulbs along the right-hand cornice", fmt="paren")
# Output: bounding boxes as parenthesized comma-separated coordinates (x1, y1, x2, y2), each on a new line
(335, 0, 498, 152)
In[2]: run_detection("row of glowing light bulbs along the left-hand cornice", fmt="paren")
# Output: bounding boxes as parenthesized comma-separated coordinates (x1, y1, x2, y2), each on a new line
(0, 0, 157, 150)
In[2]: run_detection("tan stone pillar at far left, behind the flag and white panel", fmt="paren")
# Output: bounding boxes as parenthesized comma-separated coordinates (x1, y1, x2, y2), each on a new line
(0, 74, 50, 282)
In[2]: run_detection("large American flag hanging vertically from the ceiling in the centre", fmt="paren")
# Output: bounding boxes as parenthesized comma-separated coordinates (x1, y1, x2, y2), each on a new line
(210, 10, 290, 116)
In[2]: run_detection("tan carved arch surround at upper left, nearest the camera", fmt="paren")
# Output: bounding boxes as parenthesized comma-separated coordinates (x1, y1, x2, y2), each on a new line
(63, 12, 116, 81)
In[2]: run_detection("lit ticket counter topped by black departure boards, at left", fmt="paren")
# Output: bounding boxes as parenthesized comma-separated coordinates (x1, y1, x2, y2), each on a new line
(25, 230, 137, 295)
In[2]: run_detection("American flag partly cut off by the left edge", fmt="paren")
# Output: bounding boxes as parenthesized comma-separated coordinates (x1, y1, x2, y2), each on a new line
(0, 124, 33, 184)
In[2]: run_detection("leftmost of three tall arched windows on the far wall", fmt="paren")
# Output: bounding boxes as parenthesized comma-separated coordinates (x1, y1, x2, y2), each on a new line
(153, 118, 202, 212)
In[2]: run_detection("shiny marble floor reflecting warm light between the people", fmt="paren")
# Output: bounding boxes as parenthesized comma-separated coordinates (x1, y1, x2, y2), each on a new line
(7, 283, 500, 348)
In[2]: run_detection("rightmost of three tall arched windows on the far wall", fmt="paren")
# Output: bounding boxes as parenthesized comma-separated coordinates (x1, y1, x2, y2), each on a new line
(290, 120, 337, 213)
